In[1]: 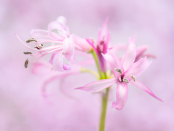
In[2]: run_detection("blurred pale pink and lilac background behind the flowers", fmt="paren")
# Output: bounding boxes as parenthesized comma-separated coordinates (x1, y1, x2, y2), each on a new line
(0, 0, 174, 131)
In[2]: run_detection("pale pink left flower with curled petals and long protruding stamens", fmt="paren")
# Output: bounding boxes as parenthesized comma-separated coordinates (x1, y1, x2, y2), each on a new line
(16, 16, 91, 71)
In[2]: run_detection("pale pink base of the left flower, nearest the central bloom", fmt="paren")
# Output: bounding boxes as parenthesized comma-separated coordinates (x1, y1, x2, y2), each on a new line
(73, 35, 92, 52)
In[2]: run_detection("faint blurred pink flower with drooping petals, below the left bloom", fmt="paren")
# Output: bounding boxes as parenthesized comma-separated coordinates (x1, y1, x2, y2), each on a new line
(32, 54, 94, 97)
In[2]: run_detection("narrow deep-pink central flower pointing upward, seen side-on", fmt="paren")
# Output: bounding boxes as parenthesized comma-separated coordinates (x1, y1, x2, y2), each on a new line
(86, 18, 110, 72)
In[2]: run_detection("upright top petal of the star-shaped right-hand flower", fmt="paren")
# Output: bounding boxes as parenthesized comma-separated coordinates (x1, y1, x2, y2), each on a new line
(122, 38, 136, 71)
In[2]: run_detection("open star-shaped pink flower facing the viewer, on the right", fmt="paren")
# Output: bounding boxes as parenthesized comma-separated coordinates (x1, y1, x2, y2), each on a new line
(76, 39, 162, 110)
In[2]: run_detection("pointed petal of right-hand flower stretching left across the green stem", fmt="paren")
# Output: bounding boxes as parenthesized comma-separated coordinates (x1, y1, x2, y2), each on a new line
(75, 78, 115, 92)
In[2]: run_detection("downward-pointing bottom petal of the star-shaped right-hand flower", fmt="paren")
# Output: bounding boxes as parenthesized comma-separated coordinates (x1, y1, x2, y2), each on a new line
(112, 83, 128, 110)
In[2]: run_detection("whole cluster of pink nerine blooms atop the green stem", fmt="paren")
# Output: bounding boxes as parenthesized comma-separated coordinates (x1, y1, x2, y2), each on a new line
(16, 16, 162, 110)
